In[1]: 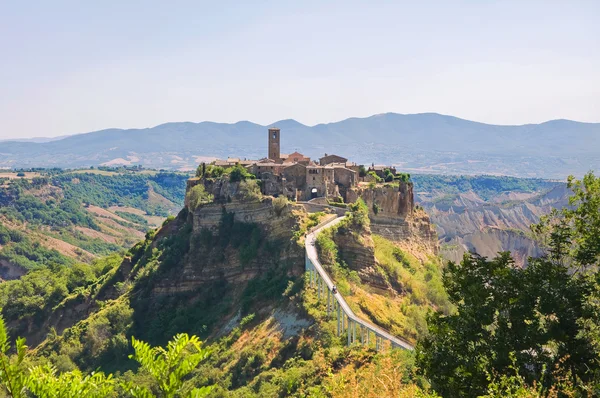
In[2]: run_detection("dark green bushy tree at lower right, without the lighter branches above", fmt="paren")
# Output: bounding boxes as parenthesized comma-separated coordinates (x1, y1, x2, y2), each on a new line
(419, 253, 598, 396)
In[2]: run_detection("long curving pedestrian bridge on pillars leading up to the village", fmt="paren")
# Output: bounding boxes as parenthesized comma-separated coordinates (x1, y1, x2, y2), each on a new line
(305, 216, 414, 351)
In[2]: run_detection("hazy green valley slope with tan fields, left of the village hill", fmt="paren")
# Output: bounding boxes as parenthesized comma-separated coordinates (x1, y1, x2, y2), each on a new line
(0, 170, 186, 276)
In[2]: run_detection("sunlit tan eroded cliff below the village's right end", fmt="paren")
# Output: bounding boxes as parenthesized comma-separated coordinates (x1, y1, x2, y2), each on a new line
(347, 182, 439, 254)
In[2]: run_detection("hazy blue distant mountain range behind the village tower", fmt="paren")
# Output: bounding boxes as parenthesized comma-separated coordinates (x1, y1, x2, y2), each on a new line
(0, 113, 600, 179)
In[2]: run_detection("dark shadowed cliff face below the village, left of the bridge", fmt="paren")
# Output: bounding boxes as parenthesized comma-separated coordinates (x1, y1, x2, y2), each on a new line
(154, 197, 304, 294)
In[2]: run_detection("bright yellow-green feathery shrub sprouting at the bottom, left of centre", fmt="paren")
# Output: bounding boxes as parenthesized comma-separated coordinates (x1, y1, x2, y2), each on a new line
(130, 333, 212, 398)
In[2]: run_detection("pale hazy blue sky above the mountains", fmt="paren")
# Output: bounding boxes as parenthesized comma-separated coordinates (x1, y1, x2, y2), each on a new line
(0, 0, 600, 140)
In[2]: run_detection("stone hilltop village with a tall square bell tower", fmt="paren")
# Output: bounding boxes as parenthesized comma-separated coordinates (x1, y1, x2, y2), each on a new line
(206, 128, 398, 202)
